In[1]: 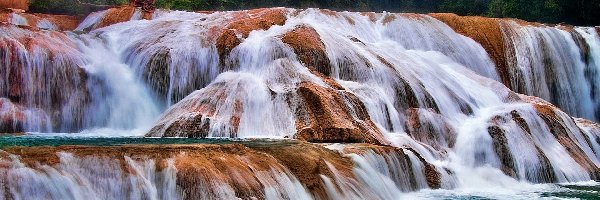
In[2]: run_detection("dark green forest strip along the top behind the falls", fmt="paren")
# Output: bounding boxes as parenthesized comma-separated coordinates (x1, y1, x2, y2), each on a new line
(30, 0, 600, 25)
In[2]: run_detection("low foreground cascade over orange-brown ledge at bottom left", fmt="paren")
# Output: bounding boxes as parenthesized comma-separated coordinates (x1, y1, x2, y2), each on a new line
(0, 145, 319, 200)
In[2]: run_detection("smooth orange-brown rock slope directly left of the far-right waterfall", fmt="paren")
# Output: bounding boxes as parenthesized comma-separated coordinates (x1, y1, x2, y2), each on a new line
(429, 13, 513, 88)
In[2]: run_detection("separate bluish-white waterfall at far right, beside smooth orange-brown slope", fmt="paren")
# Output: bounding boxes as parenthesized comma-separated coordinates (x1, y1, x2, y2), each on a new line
(501, 21, 600, 120)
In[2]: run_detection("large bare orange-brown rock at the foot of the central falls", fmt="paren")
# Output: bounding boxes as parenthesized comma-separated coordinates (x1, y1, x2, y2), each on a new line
(296, 82, 386, 144)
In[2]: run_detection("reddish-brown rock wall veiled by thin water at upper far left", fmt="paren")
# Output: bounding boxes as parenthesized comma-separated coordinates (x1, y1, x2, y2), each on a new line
(0, 24, 89, 132)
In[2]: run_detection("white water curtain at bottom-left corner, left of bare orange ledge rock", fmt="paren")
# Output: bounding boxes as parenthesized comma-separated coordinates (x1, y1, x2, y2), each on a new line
(0, 153, 181, 199)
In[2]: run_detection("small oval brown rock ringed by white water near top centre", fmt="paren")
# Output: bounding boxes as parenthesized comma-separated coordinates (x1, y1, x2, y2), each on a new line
(281, 26, 331, 76)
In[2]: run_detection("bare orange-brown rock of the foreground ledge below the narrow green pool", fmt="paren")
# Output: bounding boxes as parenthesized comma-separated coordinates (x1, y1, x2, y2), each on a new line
(0, 141, 393, 199)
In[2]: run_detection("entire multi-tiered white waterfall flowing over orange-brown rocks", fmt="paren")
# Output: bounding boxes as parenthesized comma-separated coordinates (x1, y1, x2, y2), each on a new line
(0, 5, 600, 199)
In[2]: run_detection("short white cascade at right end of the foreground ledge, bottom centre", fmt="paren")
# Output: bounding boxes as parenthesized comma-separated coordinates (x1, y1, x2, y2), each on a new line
(321, 144, 440, 199)
